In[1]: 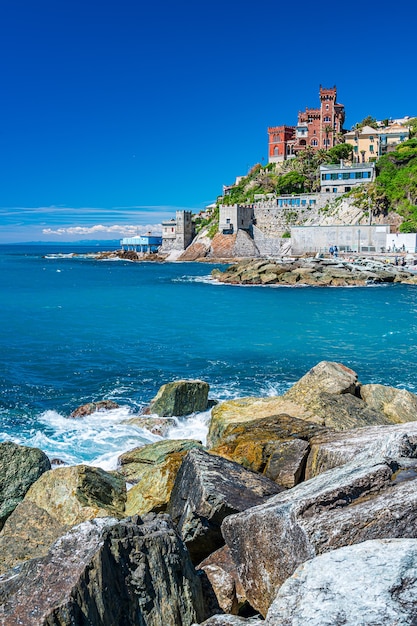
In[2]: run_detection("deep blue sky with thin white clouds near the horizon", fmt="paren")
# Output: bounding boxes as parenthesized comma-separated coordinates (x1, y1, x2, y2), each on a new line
(0, 0, 417, 243)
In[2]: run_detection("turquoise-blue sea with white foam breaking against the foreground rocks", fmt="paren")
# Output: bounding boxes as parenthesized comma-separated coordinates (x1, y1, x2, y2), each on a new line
(0, 244, 417, 469)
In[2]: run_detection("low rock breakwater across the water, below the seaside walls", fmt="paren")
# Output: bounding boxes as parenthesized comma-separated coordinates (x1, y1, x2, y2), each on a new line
(212, 257, 417, 287)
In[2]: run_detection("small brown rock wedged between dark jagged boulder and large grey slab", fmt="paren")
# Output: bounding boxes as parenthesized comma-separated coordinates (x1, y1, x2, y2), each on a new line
(196, 546, 247, 615)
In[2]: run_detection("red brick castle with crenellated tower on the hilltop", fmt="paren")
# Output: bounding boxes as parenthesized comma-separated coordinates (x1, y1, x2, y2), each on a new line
(268, 85, 345, 163)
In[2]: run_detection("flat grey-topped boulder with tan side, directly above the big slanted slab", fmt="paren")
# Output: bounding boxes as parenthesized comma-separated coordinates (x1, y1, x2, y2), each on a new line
(305, 422, 417, 480)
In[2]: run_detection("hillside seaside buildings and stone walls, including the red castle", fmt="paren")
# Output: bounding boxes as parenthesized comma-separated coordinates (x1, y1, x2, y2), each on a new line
(120, 86, 417, 265)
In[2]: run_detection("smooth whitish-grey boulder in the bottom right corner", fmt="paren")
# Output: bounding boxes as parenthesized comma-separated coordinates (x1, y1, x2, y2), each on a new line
(264, 539, 417, 626)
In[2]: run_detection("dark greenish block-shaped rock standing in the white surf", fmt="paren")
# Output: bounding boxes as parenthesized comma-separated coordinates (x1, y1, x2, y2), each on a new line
(149, 380, 209, 417)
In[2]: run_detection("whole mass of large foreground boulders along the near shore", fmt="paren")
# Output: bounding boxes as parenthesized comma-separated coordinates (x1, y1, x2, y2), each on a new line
(0, 361, 417, 626)
